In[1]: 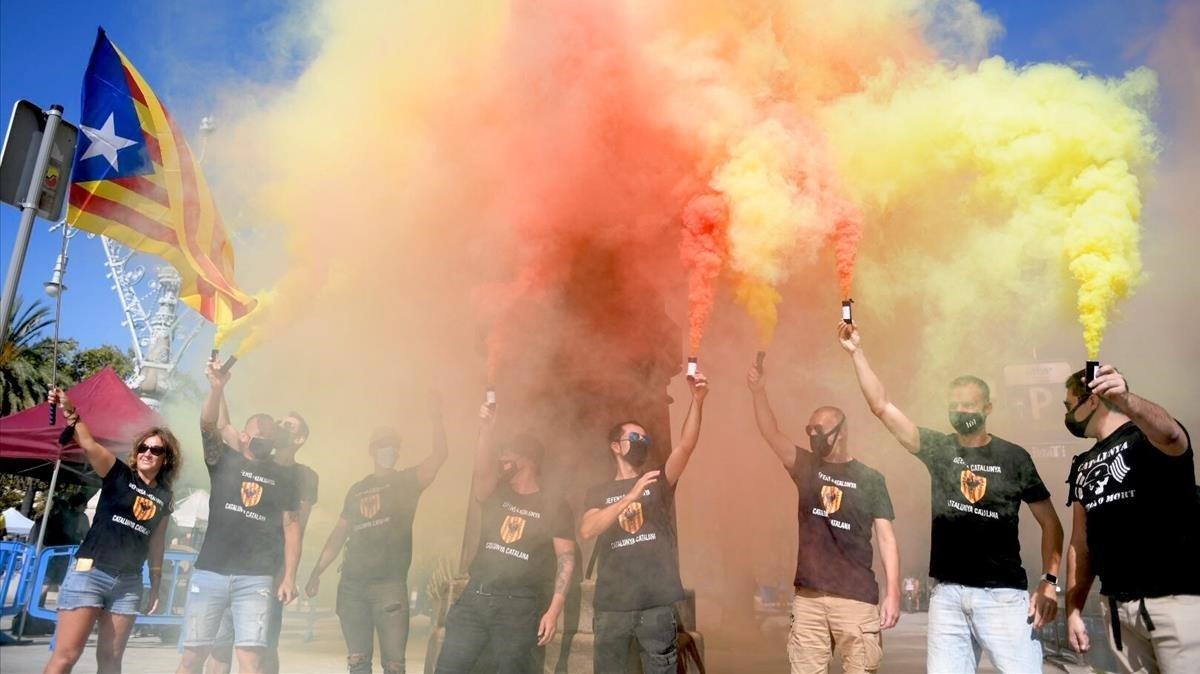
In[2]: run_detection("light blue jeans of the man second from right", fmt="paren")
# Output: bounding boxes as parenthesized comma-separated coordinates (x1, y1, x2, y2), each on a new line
(925, 583, 1042, 674)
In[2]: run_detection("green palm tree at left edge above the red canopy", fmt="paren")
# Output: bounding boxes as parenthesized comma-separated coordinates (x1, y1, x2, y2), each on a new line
(0, 297, 54, 416)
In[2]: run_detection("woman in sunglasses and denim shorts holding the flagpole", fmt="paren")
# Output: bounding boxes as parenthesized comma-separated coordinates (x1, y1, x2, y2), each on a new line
(43, 389, 181, 674)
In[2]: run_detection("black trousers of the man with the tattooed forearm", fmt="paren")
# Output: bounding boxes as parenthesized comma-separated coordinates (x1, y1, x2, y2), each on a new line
(436, 586, 546, 674)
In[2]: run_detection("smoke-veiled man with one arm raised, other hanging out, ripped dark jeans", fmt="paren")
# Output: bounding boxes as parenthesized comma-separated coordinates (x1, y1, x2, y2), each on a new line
(305, 398, 448, 674)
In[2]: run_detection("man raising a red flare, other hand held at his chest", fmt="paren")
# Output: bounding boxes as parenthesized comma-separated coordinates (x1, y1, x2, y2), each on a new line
(580, 372, 708, 674)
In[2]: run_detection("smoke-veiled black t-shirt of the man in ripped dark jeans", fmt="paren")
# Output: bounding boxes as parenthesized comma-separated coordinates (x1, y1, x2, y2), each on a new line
(342, 468, 421, 580)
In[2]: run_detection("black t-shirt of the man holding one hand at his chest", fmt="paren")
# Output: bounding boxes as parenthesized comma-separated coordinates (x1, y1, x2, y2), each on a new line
(583, 476, 683, 610)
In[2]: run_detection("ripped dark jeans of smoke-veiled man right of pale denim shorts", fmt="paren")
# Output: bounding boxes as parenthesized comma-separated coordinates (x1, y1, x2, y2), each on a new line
(337, 578, 408, 674)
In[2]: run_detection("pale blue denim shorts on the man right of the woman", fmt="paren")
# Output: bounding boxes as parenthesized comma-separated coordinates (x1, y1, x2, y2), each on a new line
(184, 570, 274, 648)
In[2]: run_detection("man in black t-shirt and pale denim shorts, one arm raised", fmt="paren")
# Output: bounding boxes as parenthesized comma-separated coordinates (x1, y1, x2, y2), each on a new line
(178, 359, 300, 674)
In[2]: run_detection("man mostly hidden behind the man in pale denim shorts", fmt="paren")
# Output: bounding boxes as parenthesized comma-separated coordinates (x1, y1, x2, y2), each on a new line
(204, 410, 319, 674)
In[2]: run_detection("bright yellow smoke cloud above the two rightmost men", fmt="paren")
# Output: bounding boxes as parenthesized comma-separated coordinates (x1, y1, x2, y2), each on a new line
(822, 58, 1156, 357)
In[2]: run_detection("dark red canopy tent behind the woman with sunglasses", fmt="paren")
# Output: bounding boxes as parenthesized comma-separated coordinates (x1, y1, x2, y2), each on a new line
(0, 367, 163, 475)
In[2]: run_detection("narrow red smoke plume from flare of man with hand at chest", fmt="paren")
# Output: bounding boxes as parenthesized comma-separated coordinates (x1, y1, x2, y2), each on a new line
(679, 194, 730, 355)
